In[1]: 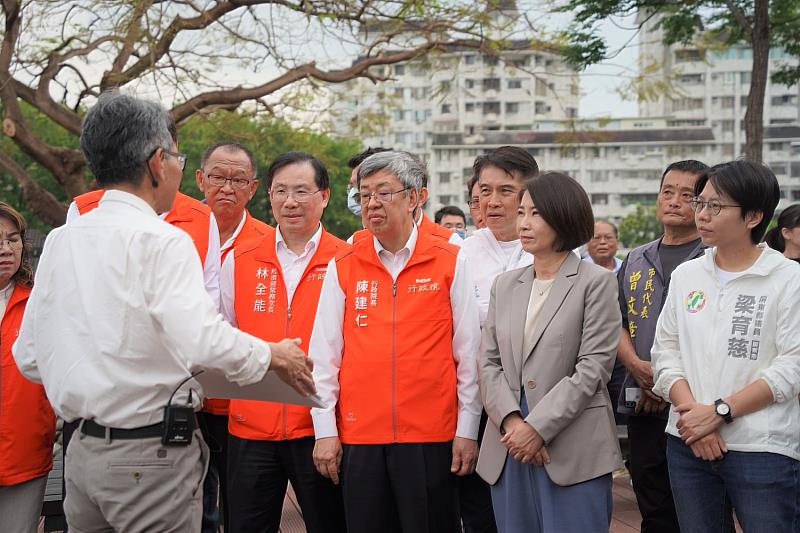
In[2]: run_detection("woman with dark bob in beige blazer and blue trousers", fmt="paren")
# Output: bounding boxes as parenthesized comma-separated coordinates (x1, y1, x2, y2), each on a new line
(478, 172, 622, 533)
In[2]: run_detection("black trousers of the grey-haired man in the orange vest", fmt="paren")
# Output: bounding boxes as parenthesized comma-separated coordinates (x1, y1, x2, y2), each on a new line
(341, 442, 461, 533)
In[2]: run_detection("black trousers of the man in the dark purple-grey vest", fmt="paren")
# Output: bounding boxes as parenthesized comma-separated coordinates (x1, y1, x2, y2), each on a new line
(628, 416, 680, 533)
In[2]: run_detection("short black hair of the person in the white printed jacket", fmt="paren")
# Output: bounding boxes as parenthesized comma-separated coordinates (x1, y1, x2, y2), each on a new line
(694, 159, 781, 244)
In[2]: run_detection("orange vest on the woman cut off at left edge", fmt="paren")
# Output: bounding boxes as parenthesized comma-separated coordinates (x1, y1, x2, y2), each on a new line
(0, 285, 56, 486)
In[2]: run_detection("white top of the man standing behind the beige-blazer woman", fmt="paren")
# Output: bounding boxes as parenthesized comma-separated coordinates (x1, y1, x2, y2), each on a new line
(461, 228, 533, 324)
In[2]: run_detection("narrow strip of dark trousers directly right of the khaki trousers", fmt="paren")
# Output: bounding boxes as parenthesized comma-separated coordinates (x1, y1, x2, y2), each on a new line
(197, 412, 229, 533)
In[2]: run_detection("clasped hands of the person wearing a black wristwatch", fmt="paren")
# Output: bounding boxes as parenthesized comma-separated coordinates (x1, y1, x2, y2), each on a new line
(674, 401, 728, 461)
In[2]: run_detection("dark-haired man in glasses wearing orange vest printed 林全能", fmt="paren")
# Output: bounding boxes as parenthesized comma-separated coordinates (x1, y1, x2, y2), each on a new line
(220, 152, 348, 533)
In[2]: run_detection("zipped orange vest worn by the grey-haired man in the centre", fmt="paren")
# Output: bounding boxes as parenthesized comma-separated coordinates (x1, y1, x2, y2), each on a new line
(336, 231, 458, 444)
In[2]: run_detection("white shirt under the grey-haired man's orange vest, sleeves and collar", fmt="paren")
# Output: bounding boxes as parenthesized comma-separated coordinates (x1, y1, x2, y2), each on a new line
(308, 226, 481, 439)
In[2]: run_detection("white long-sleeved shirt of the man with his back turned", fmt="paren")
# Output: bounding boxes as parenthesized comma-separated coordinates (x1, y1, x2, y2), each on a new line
(13, 190, 270, 428)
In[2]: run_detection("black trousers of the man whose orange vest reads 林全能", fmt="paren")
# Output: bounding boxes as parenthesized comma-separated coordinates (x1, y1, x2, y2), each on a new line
(225, 435, 345, 533)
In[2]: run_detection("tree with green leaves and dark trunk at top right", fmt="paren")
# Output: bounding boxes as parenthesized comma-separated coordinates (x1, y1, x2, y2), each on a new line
(555, 0, 800, 161)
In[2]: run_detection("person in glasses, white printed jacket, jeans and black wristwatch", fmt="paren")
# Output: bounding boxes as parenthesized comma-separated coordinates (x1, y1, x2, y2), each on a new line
(652, 160, 800, 533)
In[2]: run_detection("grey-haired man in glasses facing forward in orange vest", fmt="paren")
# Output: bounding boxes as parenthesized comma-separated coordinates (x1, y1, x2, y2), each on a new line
(309, 152, 481, 533)
